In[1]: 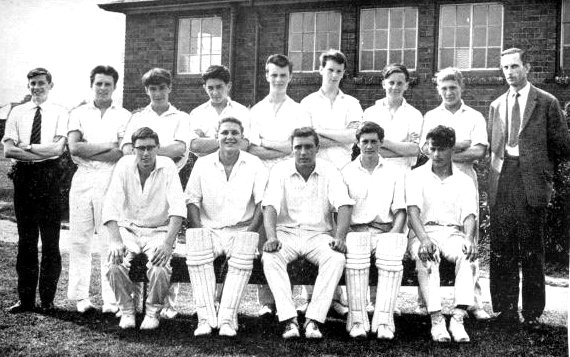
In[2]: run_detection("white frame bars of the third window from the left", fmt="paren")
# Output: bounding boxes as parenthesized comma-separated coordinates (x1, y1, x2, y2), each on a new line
(358, 6, 419, 72)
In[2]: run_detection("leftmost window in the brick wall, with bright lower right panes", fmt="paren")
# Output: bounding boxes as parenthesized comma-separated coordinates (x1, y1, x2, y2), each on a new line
(177, 17, 222, 74)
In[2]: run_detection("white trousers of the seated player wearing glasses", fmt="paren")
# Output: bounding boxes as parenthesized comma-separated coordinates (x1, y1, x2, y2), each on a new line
(107, 226, 172, 316)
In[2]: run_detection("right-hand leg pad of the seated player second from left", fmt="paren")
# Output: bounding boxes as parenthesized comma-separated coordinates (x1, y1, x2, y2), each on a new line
(218, 232, 259, 331)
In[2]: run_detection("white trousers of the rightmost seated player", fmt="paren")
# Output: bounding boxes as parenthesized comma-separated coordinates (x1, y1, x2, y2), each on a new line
(409, 226, 477, 313)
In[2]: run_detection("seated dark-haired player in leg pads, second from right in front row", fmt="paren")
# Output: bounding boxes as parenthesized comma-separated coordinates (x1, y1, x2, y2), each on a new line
(342, 122, 407, 340)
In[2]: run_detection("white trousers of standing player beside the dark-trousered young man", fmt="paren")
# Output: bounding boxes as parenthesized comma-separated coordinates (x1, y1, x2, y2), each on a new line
(67, 167, 116, 304)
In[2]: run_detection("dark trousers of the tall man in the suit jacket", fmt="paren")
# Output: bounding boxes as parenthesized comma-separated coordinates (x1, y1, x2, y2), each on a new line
(490, 158, 546, 318)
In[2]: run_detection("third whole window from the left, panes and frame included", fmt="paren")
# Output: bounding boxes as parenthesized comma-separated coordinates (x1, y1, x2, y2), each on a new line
(359, 8, 418, 71)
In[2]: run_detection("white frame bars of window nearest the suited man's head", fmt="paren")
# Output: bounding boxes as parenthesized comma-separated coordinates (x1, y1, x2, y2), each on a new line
(437, 2, 505, 71)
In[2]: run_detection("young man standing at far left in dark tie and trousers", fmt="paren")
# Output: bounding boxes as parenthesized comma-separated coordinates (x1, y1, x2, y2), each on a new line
(2, 68, 68, 313)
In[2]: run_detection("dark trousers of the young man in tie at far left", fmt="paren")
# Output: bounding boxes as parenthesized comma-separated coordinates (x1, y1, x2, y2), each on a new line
(12, 160, 61, 304)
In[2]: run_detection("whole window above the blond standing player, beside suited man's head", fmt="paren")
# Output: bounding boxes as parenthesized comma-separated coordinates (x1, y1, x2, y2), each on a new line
(438, 3, 503, 69)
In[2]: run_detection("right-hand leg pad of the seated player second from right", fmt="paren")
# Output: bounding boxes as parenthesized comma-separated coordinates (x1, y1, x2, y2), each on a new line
(371, 233, 407, 332)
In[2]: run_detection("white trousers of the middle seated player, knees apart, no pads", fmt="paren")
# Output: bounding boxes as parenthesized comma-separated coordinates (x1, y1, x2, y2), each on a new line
(262, 229, 345, 323)
